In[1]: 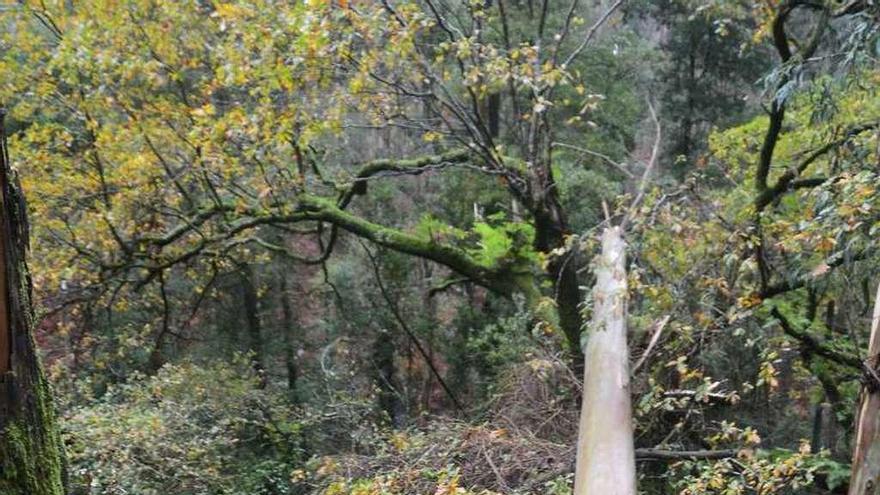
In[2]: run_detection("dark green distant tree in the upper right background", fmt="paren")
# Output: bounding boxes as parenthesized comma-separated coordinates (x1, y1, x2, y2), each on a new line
(646, 0, 770, 163)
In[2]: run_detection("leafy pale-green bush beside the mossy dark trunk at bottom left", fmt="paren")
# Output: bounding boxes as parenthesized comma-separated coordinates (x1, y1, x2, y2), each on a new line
(65, 356, 308, 495)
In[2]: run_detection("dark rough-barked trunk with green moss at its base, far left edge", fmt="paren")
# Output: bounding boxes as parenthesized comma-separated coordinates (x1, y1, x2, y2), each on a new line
(0, 110, 65, 495)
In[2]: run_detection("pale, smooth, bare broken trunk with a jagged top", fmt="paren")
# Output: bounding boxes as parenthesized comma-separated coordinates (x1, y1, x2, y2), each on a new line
(574, 227, 636, 495)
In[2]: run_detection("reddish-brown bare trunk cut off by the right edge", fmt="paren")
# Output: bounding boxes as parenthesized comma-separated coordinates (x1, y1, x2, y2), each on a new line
(849, 287, 880, 495)
